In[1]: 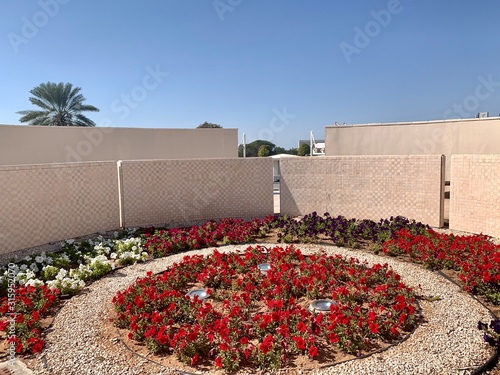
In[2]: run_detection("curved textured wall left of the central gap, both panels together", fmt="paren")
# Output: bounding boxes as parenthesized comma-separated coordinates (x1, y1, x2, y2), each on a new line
(0, 158, 274, 260)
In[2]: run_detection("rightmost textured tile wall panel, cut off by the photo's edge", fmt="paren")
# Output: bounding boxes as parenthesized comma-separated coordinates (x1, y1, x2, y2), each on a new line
(450, 155, 500, 237)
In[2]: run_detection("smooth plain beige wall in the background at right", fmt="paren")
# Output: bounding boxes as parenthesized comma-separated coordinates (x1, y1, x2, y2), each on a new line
(325, 117, 500, 181)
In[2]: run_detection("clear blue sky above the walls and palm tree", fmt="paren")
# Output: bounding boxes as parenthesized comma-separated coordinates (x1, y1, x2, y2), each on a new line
(0, 0, 500, 148)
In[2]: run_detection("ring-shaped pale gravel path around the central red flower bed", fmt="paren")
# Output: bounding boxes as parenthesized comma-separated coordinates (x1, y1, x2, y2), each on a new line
(30, 244, 492, 375)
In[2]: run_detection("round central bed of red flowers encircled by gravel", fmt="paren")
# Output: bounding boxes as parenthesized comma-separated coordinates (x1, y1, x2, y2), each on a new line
(113, 246, 417, 371)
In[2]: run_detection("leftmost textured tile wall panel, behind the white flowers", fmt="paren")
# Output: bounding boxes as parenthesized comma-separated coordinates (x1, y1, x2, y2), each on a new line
(0, 162, 119, 255)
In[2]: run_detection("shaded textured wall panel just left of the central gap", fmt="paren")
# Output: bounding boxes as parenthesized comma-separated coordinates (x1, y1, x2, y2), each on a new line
(121, 158, 273, 226)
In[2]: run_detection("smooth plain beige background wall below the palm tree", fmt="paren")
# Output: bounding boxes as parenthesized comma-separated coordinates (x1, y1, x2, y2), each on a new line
(0, 125, 238, 165)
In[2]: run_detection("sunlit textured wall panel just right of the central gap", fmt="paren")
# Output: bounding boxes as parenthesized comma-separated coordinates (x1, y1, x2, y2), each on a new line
(280, 155, 444, 227)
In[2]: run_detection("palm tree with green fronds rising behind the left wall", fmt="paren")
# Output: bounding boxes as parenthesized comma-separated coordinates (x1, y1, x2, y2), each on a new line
(17, 82, 99, 126)
